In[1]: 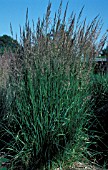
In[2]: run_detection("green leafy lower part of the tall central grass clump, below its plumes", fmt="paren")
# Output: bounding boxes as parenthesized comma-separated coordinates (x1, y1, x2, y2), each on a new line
(1, 64, 90, 169)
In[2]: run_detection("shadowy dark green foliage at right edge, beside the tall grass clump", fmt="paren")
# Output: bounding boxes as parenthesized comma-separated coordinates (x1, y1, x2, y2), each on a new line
(90, 74, 108, 166)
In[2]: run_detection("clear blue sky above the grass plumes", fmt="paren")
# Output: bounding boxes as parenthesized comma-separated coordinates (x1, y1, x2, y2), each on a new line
(0, 0, 108, 42)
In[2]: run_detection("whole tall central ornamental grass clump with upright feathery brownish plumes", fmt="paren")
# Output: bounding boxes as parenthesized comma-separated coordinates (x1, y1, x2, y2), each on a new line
(2, 2, 106, 170)
